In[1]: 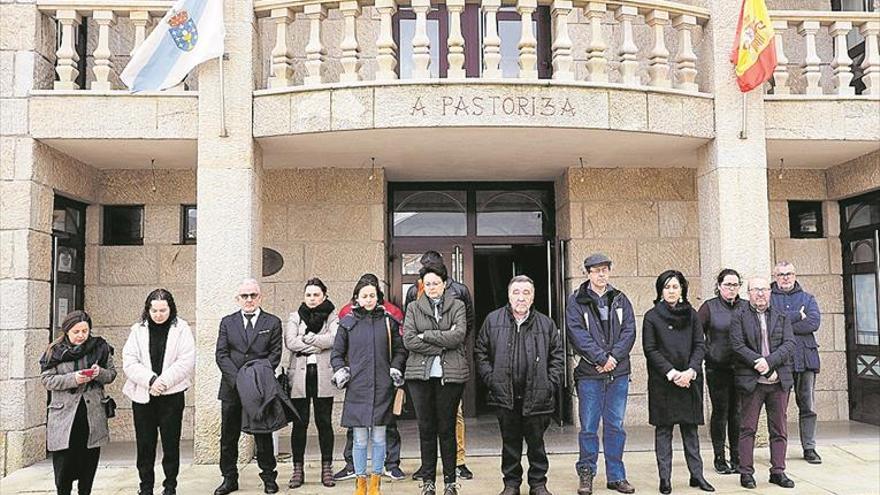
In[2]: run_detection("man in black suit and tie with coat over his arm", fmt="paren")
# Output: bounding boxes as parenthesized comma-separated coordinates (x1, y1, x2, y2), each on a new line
(214, 279, 282, 495)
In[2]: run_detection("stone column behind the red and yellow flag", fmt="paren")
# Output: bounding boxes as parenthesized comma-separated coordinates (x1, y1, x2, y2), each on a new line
(697, 2, 771, 297)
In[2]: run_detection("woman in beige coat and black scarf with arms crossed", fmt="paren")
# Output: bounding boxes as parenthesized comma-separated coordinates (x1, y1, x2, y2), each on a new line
(284, 278, 339, 488)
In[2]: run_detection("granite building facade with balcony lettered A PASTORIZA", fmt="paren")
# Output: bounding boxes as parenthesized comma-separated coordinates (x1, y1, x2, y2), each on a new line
(0, 0, 880, 475)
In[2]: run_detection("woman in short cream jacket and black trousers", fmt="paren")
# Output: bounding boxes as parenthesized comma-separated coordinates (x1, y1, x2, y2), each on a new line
(122, 289, 196, 495)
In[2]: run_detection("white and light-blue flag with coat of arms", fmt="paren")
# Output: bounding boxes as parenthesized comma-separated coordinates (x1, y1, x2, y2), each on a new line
(120, 0, 223, 92)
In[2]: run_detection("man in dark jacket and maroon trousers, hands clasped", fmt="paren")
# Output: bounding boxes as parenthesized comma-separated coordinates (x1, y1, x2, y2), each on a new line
(730, 278, 795, 488)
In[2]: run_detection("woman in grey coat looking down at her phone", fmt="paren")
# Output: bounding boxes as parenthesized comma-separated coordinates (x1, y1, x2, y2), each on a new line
(40, 311, 116, 495)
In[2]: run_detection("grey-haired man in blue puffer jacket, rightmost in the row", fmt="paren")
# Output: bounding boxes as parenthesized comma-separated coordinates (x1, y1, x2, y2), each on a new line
(770, 261, 822, 464)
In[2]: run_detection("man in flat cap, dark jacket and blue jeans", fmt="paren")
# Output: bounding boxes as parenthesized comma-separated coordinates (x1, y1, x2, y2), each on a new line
(565, 253, 636, 495)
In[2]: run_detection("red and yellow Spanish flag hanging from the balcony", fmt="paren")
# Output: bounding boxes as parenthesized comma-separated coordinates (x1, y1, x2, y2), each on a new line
(730, 0, 776, 93)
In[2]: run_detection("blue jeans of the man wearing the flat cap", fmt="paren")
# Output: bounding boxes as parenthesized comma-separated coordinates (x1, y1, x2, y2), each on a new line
(577, 375, 629, 482)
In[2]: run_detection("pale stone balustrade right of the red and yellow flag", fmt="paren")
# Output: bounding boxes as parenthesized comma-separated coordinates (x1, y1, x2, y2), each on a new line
(767, 10, 880, 96)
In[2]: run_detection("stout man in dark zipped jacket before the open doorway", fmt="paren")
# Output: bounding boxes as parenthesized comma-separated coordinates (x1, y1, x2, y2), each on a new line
(474, 275, 564, 495)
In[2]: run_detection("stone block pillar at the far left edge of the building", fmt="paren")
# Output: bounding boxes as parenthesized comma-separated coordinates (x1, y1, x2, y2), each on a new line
(0, 3, 55, 477)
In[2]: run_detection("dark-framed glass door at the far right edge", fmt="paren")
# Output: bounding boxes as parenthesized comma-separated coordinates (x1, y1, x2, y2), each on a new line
(840, 192, 880, 425)
